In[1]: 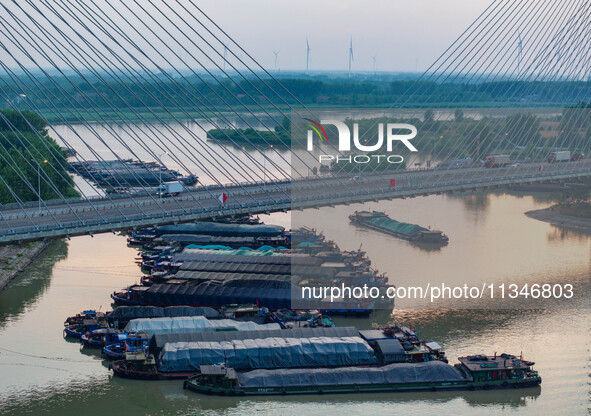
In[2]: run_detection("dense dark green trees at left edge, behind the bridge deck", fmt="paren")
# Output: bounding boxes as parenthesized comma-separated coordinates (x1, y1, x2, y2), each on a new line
(0, 110, 78, 204)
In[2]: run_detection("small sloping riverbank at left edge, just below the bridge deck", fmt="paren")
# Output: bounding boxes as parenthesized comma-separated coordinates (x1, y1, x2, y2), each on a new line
(0, 241, 51, 292)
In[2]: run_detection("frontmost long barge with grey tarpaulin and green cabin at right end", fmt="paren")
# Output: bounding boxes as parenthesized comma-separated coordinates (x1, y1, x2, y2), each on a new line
(184, 354, 542, 396)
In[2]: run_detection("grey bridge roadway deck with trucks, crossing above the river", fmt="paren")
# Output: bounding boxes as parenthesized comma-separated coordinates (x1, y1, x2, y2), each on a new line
(0, 160, 591, 242)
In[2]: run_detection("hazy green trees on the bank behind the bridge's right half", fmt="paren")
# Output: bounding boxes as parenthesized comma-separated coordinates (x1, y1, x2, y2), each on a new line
(326, 107, 591, 161)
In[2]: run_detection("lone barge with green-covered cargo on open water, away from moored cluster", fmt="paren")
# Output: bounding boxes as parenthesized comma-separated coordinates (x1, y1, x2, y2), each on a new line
(349, 211, 449, 245)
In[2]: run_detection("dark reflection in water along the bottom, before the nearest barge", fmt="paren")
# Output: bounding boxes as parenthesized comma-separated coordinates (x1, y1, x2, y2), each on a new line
(0, 378, 541, 416)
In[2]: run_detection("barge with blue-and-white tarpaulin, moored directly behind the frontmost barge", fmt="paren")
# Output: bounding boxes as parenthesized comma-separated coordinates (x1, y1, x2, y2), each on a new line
(110, 327, 374, 380)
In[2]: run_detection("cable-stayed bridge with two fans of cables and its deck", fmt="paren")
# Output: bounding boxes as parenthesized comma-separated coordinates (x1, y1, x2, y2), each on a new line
(0, 0, 591, 243)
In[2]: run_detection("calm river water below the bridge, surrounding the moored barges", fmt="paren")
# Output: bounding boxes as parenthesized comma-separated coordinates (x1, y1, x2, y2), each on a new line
(0, 193, 591, 416)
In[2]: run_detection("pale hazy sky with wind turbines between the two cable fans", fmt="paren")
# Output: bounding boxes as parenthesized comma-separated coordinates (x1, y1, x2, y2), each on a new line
(197, 0, 492, 71)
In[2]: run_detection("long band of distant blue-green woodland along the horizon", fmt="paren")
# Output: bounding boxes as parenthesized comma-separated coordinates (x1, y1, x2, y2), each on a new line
(0, 75, 591, 123)
